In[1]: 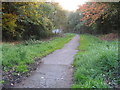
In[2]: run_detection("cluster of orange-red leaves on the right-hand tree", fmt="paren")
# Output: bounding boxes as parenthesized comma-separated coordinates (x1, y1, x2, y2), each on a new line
(78, 2, 109, 26)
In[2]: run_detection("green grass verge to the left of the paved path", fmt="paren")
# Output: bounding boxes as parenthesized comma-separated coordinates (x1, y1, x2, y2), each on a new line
(2, 34, 74, 84)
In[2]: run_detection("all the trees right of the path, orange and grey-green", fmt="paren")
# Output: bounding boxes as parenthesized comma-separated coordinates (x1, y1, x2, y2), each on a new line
(68, 2, 120, 34)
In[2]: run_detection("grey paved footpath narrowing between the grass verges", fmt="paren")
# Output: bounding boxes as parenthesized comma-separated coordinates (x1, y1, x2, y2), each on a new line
(15, 35, 79, 88)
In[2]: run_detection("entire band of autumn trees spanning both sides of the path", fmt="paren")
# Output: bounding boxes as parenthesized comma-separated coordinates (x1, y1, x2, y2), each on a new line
(2, 2, 120, 41)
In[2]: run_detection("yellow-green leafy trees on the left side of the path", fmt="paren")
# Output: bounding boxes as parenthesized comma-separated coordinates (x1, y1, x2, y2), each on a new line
(2, 2, 66, 41)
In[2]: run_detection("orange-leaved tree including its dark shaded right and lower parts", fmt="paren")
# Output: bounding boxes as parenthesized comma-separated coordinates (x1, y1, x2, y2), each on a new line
(77, 2, 120, 33)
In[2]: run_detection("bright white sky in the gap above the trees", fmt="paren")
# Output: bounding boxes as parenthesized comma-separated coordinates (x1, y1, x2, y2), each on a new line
(53, 0, 87, 11)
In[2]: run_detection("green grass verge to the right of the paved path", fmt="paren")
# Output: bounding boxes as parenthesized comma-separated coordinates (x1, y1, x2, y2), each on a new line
(72, 35, 120, 88)
